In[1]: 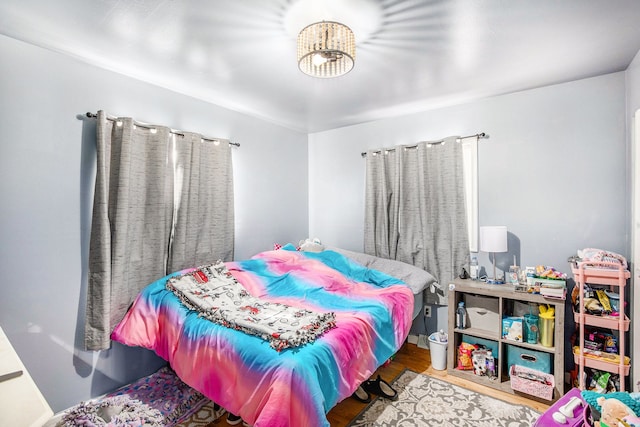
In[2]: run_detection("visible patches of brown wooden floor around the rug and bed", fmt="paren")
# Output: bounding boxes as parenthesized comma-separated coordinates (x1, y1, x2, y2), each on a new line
(216, 343, 549, 427)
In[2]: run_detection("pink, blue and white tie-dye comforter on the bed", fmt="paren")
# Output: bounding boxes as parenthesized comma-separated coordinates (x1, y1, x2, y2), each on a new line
(112, 245, 414, 427)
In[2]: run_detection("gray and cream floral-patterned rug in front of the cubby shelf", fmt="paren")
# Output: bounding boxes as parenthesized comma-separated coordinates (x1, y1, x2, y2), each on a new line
(348, 369, 540, 427)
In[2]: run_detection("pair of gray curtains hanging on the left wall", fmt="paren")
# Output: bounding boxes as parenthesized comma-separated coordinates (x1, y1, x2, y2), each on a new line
(85, 111, 234, 350)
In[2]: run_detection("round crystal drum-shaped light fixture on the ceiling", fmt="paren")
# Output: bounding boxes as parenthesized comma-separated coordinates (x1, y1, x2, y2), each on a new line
(298, 21, 356, 78)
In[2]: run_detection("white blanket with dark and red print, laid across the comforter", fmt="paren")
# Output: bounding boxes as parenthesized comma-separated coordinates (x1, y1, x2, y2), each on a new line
(166, 261, 335, 351)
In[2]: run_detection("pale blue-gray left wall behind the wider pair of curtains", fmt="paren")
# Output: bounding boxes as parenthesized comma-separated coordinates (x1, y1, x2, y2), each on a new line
(0, 36, 308, 411)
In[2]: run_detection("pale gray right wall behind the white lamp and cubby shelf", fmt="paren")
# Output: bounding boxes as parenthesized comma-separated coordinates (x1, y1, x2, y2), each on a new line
(309, 72, 630, 333)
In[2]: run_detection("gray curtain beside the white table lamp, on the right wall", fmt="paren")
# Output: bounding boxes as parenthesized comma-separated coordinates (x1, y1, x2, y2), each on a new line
(364, 137, 469, 304)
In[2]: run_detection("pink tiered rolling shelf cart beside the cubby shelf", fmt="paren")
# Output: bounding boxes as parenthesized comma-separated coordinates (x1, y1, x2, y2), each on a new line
(571, 262, 631, 391)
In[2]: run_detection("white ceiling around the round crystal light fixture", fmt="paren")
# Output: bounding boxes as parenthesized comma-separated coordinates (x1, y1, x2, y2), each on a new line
(0, 0, 640, 133)
